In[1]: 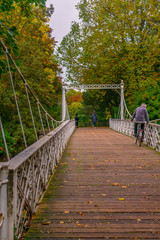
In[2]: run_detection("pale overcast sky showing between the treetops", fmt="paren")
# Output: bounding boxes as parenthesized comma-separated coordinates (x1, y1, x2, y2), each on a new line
(46, 0, 80, 44)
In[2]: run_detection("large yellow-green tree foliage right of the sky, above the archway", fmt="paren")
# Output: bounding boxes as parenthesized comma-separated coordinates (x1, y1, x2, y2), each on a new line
(58, 0, 160, 117)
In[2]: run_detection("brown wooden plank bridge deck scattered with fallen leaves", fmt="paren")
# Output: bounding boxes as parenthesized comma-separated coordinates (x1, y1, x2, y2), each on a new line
(25, 128, 160, 240)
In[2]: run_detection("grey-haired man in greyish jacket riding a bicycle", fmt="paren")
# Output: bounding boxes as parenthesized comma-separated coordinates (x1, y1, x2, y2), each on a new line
(131, 103, 149, 138)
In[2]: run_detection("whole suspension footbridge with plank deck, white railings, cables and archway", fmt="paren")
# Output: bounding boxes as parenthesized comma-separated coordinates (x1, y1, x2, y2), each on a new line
(0, 40, 160, 240)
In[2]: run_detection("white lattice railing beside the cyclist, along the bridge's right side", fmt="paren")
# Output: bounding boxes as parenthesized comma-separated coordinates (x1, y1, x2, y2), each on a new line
(109, 119, 160, 152)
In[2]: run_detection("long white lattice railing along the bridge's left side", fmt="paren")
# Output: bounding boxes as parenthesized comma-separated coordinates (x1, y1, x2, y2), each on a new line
(4, 120, 75, 240)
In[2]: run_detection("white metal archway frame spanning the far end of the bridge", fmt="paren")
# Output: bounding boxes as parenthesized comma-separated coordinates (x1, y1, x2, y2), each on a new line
(62, 80, 124, 120)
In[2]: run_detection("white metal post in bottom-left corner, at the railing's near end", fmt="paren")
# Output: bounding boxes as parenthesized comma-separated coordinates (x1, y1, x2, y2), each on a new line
(0, 163, 9, 240)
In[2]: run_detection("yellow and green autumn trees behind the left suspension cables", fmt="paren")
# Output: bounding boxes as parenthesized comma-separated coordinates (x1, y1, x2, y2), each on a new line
(0, 0, 62, 156)
